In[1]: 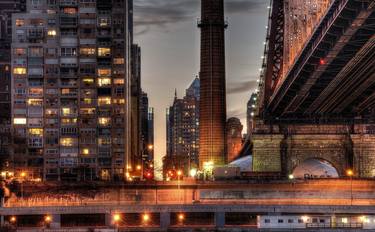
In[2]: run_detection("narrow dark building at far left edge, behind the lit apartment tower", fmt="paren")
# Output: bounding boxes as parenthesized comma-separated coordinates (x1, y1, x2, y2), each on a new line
(0, 0, 26, 170)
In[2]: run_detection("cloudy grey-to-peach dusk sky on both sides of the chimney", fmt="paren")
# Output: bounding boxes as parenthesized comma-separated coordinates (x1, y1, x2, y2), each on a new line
(134, 0, 269, 162)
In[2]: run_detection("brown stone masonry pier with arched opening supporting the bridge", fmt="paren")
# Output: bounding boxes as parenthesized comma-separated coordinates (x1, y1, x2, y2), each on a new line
(252, 125, 375, 178)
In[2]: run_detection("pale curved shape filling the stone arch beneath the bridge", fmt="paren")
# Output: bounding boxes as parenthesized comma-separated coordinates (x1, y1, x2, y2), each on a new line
(293, 159, 339, 178)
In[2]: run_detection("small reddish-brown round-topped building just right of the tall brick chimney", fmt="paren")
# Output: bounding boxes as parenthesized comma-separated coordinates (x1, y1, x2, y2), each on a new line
(227, 117, 243, 162)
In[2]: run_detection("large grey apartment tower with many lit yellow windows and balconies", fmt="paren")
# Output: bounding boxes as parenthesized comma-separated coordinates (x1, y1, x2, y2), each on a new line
(11, 0, 132, 180)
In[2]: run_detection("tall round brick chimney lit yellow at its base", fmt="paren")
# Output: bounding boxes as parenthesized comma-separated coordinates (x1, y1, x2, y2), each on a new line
(198, 0, 227, 168)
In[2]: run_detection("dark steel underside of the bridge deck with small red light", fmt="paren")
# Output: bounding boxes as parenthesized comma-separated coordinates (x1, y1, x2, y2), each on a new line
(264, 0, 375, 122)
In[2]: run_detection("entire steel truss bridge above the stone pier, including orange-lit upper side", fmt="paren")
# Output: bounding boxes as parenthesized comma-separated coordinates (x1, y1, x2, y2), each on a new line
(258, 0, 375, 122)
